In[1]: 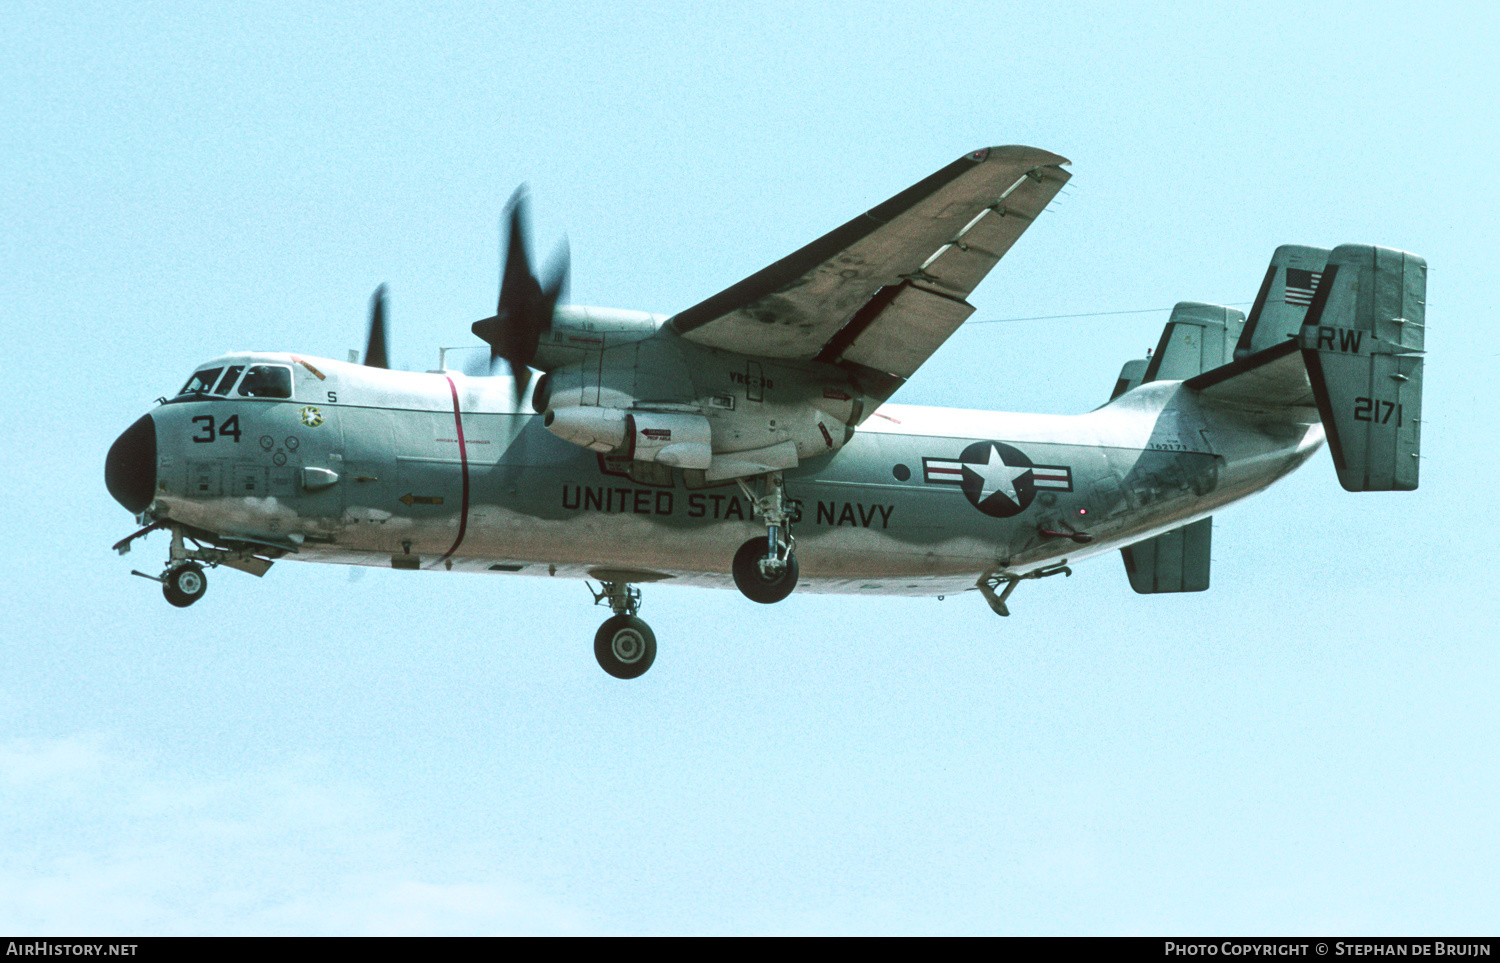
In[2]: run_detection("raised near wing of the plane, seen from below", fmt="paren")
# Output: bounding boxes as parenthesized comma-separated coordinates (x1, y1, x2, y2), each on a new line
(669, 147, 1070, 382)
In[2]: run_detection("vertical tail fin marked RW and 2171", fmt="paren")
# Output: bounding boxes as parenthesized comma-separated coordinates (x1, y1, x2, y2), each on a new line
(1298, 245, 1427, 492)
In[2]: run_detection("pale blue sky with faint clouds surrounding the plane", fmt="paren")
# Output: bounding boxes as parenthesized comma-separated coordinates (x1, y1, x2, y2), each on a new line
(0, 3, 1500, 935)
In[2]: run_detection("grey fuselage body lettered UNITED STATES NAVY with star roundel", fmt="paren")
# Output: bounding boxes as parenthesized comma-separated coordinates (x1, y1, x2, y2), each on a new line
(135, 354, 1323, 596)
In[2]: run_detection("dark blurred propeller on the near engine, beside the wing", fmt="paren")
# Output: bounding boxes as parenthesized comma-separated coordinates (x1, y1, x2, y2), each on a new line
(473, 186, 569, 404)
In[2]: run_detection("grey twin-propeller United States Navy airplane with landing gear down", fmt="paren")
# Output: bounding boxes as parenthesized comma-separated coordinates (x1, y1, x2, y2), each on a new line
(105, 147, 1427, 678)
